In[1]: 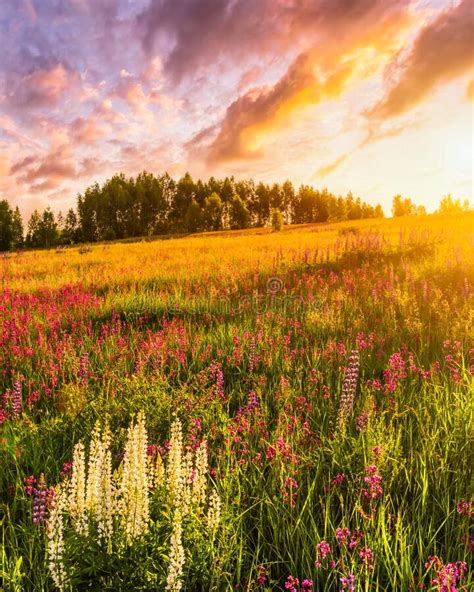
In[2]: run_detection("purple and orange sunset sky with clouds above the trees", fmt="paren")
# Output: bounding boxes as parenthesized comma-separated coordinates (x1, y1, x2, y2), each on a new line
(0, 0, 474, 215)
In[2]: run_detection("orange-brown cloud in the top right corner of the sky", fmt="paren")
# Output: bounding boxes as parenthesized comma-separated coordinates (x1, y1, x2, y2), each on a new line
(368, 0, 474, 119)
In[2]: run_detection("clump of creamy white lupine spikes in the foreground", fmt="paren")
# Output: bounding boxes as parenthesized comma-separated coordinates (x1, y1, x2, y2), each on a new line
(47, 413, 221, 592)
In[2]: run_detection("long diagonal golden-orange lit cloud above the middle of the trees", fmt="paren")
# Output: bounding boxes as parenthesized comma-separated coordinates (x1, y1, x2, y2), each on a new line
(198, 3, 409, 164)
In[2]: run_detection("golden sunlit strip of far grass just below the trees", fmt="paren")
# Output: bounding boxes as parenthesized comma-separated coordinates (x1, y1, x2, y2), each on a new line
(0, 212, 474, 292)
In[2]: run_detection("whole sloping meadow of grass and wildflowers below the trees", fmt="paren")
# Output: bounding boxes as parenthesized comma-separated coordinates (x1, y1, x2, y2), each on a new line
(0, 214, 474, 592)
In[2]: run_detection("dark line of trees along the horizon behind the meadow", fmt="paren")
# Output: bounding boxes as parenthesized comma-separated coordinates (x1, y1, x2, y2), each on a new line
(0, 172, 470, 251)
